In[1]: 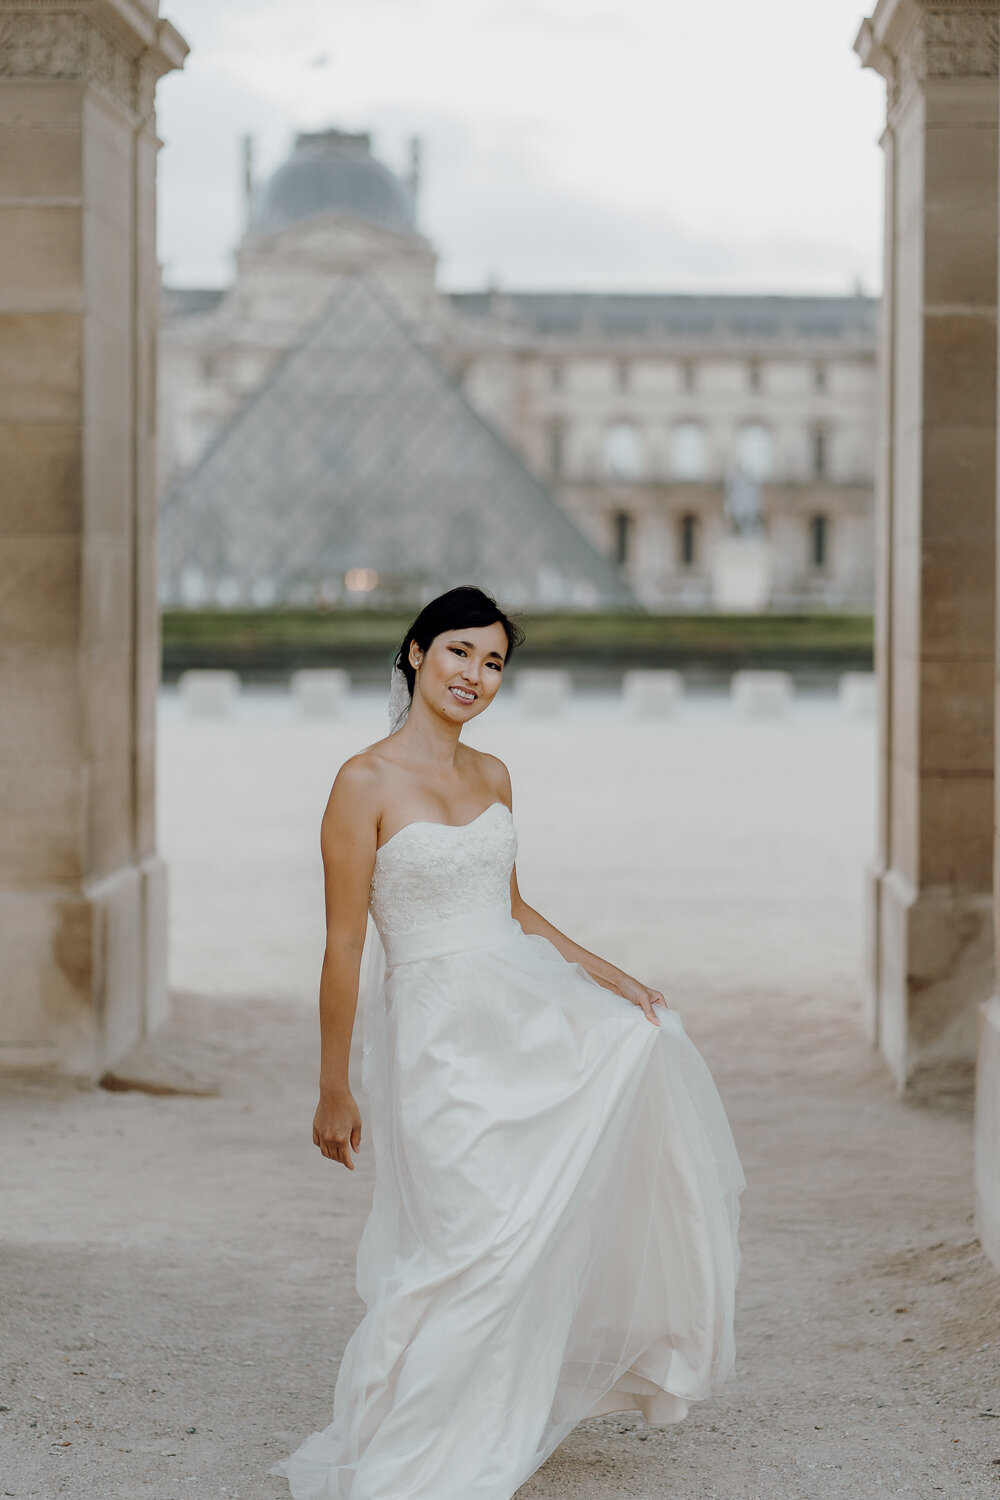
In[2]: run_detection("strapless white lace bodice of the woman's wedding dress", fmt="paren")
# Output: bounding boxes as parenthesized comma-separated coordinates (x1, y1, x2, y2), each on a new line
(369, 803, 517, 935)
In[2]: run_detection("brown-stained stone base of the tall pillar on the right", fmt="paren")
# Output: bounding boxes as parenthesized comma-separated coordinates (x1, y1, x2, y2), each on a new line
(870, 870, 996, 1092)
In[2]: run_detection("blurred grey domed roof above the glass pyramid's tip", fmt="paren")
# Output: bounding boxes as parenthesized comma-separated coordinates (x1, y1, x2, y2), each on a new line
(250, 131, 414, 234)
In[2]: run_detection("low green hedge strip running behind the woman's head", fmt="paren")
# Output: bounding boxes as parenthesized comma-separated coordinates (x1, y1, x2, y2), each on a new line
(163, 609, 873, 678)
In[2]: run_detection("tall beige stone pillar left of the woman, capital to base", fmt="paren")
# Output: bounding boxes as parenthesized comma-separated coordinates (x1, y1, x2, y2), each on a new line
(0, 0, 186, 1077)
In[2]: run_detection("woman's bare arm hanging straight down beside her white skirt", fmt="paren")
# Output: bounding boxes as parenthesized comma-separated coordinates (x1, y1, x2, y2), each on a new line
(312, 756, 378, 1170)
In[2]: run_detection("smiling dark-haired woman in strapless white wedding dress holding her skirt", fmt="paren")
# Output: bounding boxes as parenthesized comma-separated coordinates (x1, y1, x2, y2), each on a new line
(271, 587, 745, 1500)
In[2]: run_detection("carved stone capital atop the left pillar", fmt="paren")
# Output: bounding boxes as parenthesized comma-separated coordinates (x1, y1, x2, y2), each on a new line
(0, 0, 187, 122)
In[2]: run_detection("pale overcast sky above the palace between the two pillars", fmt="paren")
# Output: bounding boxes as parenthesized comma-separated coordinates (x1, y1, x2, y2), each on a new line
(157, 0, 885, 293)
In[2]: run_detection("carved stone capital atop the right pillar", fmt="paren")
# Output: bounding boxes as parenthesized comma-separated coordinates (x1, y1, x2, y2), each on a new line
(855, 0, 1000, 116)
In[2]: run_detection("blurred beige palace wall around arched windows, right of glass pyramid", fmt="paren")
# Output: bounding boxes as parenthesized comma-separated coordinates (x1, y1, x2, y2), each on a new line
(441, 340, 876, 609)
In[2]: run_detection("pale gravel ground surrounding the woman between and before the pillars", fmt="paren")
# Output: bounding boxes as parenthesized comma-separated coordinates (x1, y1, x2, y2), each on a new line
(0, 704, 1000, 1500)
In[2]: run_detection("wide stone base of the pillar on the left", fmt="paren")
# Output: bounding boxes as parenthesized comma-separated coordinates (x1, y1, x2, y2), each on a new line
(0, 857, 169, 1080)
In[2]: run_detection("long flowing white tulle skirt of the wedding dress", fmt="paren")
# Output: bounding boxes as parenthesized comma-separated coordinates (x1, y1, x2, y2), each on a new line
(271, 908, 745, 1500)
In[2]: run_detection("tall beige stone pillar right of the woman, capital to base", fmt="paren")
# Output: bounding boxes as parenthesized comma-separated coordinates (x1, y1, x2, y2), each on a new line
(856, 0, 1000, 1089)
